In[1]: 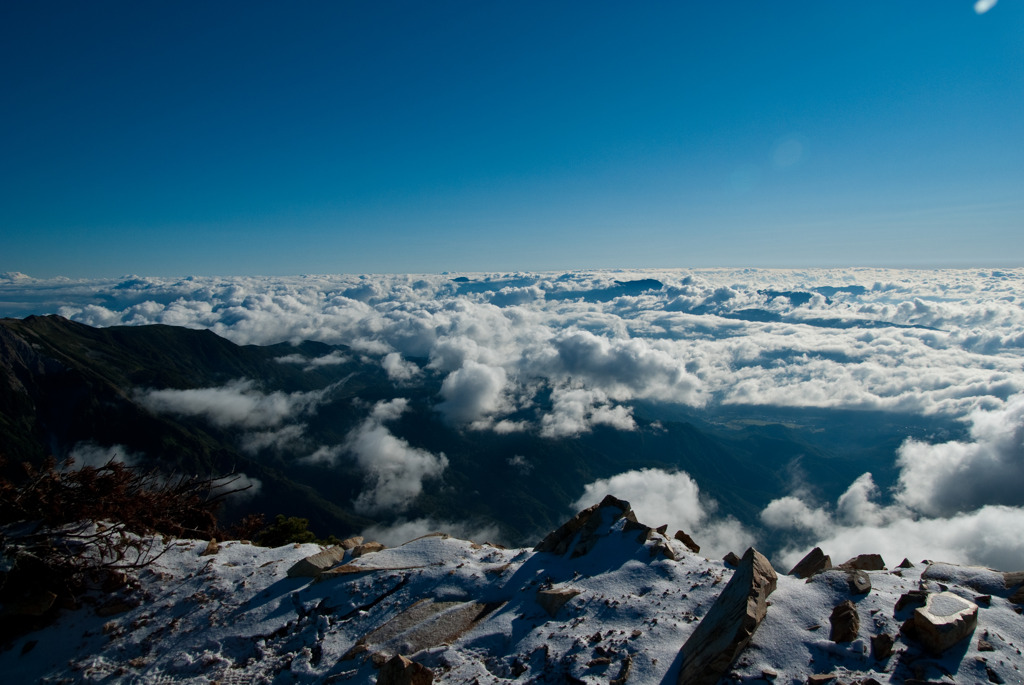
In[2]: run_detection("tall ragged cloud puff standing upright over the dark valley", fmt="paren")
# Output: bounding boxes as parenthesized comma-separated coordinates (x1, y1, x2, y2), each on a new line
(348, 399, 447, 514)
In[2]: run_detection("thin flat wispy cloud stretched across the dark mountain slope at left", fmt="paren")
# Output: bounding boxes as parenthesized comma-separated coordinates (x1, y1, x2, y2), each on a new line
(137, 379, 331, 428)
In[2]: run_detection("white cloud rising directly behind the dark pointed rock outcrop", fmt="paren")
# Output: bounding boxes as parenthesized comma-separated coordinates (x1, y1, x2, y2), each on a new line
(573, 469, 754, 557)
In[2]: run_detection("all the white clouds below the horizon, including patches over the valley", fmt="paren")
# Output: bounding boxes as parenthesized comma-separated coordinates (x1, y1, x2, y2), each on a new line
(8, 268, 1024, 567)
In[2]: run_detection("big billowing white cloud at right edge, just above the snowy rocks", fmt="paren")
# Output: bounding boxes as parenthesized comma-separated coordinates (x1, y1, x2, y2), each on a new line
(761, 395, 1024, 570)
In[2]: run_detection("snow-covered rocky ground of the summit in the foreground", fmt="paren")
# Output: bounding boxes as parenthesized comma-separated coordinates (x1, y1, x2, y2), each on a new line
(0, 509, 1024, 685)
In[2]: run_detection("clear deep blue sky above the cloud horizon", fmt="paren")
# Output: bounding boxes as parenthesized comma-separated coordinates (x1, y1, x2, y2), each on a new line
(0, 0, 1024, 277)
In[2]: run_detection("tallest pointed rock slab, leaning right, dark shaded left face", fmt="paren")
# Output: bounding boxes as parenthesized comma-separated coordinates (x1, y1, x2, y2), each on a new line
(677, 547, 778, 685)
